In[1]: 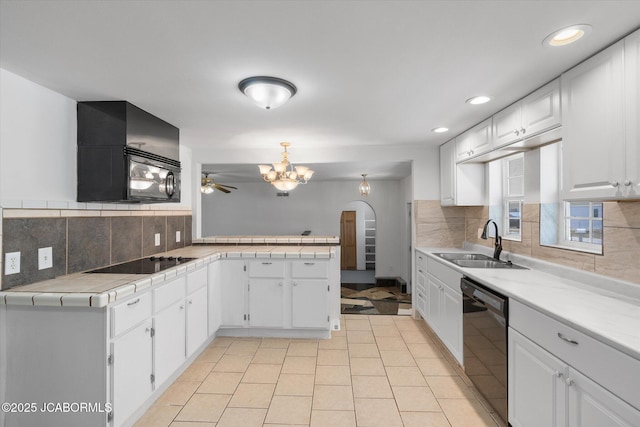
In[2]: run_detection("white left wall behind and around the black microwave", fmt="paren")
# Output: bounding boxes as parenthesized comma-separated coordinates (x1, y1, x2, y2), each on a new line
(0, 68, 193, 210)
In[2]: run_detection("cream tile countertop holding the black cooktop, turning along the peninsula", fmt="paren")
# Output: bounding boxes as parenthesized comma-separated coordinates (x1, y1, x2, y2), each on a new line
(0, 245, 336, 308)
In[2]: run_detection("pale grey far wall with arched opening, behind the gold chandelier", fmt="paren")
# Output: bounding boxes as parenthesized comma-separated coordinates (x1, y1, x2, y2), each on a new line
(201, 179, 409, 280)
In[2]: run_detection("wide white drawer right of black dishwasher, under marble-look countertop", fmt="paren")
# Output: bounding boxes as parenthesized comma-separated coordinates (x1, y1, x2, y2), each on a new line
(509, 300, 640, 408)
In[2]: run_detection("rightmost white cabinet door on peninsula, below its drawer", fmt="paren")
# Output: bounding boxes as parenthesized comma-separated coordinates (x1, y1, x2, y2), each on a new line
(291, 279, 329, 329)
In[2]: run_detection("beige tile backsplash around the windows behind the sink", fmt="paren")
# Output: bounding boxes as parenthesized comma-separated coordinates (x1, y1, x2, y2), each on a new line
(414, 200, 640, 284)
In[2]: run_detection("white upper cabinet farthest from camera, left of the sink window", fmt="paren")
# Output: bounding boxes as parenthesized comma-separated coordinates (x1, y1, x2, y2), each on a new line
(440, 139, 484, 206)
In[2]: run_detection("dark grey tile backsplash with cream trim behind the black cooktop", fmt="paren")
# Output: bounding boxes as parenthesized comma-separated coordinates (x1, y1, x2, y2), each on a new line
(0, 209, 192, 289)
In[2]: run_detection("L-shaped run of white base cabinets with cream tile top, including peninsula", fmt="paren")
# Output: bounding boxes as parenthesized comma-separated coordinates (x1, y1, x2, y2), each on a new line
(0, 236, 340, 426)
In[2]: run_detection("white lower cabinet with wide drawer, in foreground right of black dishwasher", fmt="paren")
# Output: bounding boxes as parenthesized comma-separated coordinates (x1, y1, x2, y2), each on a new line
(508, 300, 640, 427)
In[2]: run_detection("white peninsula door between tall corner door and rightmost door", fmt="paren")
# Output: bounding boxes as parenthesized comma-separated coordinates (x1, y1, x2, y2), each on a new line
(249, 278, 284, 328)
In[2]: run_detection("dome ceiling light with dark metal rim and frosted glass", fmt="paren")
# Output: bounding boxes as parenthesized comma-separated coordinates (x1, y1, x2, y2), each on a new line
(238, 76, 298, 110)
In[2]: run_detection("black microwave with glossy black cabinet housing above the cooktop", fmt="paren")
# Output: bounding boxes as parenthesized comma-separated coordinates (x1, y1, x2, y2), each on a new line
(77, 101, 180, 203)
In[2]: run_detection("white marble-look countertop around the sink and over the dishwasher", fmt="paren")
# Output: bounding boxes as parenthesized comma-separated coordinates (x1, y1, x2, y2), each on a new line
(417, 248, 640, 360)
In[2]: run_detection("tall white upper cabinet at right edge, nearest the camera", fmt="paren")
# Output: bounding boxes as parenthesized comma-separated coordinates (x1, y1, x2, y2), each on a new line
(562, 31, 640, 200)
